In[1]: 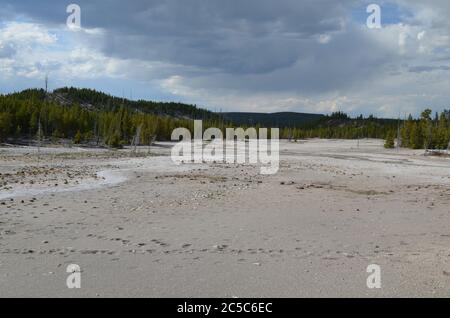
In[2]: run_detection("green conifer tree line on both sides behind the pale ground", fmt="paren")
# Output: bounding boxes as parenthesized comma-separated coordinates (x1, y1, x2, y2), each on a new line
(0, 88, 450, 149)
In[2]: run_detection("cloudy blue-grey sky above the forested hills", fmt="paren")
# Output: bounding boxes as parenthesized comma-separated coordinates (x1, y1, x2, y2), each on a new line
(0, 0, 450, 118)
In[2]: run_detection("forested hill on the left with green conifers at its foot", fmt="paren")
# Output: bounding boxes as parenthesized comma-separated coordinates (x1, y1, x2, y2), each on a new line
(0, 88, 226, 147)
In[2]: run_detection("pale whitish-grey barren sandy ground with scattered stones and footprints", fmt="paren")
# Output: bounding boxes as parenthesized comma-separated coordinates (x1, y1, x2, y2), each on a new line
(0, 140, 450, 297)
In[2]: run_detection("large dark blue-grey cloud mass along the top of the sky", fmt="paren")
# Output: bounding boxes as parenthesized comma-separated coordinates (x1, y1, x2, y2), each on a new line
(1, 0, 353, 74)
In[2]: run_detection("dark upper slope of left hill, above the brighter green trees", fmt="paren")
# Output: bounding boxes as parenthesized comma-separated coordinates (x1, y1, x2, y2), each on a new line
(7, 87, 218, 119)
